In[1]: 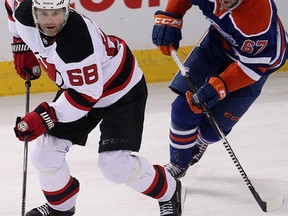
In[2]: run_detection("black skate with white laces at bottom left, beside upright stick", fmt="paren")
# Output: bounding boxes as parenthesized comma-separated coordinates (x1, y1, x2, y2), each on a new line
(25, 203, 75, 216)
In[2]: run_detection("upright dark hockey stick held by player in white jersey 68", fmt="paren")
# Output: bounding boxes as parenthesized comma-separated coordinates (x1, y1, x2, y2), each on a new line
(21, 69, 31, 216)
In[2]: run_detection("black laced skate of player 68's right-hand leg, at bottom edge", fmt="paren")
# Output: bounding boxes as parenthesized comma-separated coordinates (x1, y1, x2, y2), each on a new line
(159, 179, 186, 216)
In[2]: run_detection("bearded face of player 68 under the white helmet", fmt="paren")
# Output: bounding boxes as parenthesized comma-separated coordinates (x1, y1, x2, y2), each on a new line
(35, 8, 66, 37)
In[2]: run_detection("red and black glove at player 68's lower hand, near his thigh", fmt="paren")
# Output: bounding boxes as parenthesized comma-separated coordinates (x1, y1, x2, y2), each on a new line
(14, 102, 58, 141)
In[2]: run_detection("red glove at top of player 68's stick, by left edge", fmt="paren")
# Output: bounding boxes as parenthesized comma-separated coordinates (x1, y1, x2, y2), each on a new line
(11, 37, 41, 80)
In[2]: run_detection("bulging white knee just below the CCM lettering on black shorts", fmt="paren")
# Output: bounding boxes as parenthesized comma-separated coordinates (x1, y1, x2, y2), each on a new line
(98, 150, 139, 184)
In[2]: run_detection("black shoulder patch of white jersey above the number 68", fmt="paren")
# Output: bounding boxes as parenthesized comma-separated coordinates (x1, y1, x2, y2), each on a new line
(56, 11, 94, 63)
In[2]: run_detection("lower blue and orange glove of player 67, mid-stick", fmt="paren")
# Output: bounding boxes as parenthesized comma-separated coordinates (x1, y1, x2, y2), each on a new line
(192, 76, 228, 108)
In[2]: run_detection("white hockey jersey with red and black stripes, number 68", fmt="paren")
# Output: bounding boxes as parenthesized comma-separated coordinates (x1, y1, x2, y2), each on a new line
(5, 0, 143, 122)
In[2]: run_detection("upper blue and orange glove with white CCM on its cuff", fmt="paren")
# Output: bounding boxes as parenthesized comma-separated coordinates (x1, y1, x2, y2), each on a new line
(152, 11, 183, 55)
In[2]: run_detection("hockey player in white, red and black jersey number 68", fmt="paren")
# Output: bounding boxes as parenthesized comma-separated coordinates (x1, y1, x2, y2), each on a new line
(5, 0, 185, 216)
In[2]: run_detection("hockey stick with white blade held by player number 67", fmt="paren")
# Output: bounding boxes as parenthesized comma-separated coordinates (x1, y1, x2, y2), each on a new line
(170, 47, 284, 212)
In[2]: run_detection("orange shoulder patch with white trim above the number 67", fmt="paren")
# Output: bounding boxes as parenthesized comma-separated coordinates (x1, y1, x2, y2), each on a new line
(231, 0, 276, 36)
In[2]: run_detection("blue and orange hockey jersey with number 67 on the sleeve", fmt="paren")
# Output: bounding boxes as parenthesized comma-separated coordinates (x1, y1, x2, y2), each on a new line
(166, 0, 288, 92)
